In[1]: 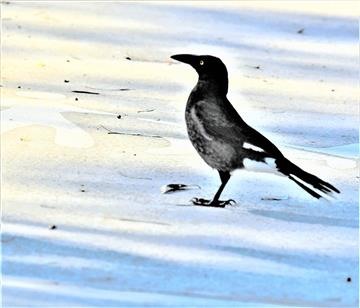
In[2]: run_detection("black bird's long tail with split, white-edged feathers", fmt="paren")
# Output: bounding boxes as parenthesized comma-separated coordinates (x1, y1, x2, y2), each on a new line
(276, 157, 340, 199)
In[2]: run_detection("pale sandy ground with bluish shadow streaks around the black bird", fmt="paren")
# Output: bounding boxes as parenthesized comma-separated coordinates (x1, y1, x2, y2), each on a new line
(1, 1, 359, 307)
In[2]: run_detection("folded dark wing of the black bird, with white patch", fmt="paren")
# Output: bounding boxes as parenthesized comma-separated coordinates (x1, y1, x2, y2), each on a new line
(193, 100, 283, 158)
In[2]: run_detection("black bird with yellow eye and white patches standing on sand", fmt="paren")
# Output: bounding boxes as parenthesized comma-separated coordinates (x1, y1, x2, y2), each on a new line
(171, 54, 340, 207)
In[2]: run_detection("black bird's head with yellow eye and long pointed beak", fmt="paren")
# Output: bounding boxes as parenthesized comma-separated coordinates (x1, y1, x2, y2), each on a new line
(171, 54, 228, 92)
